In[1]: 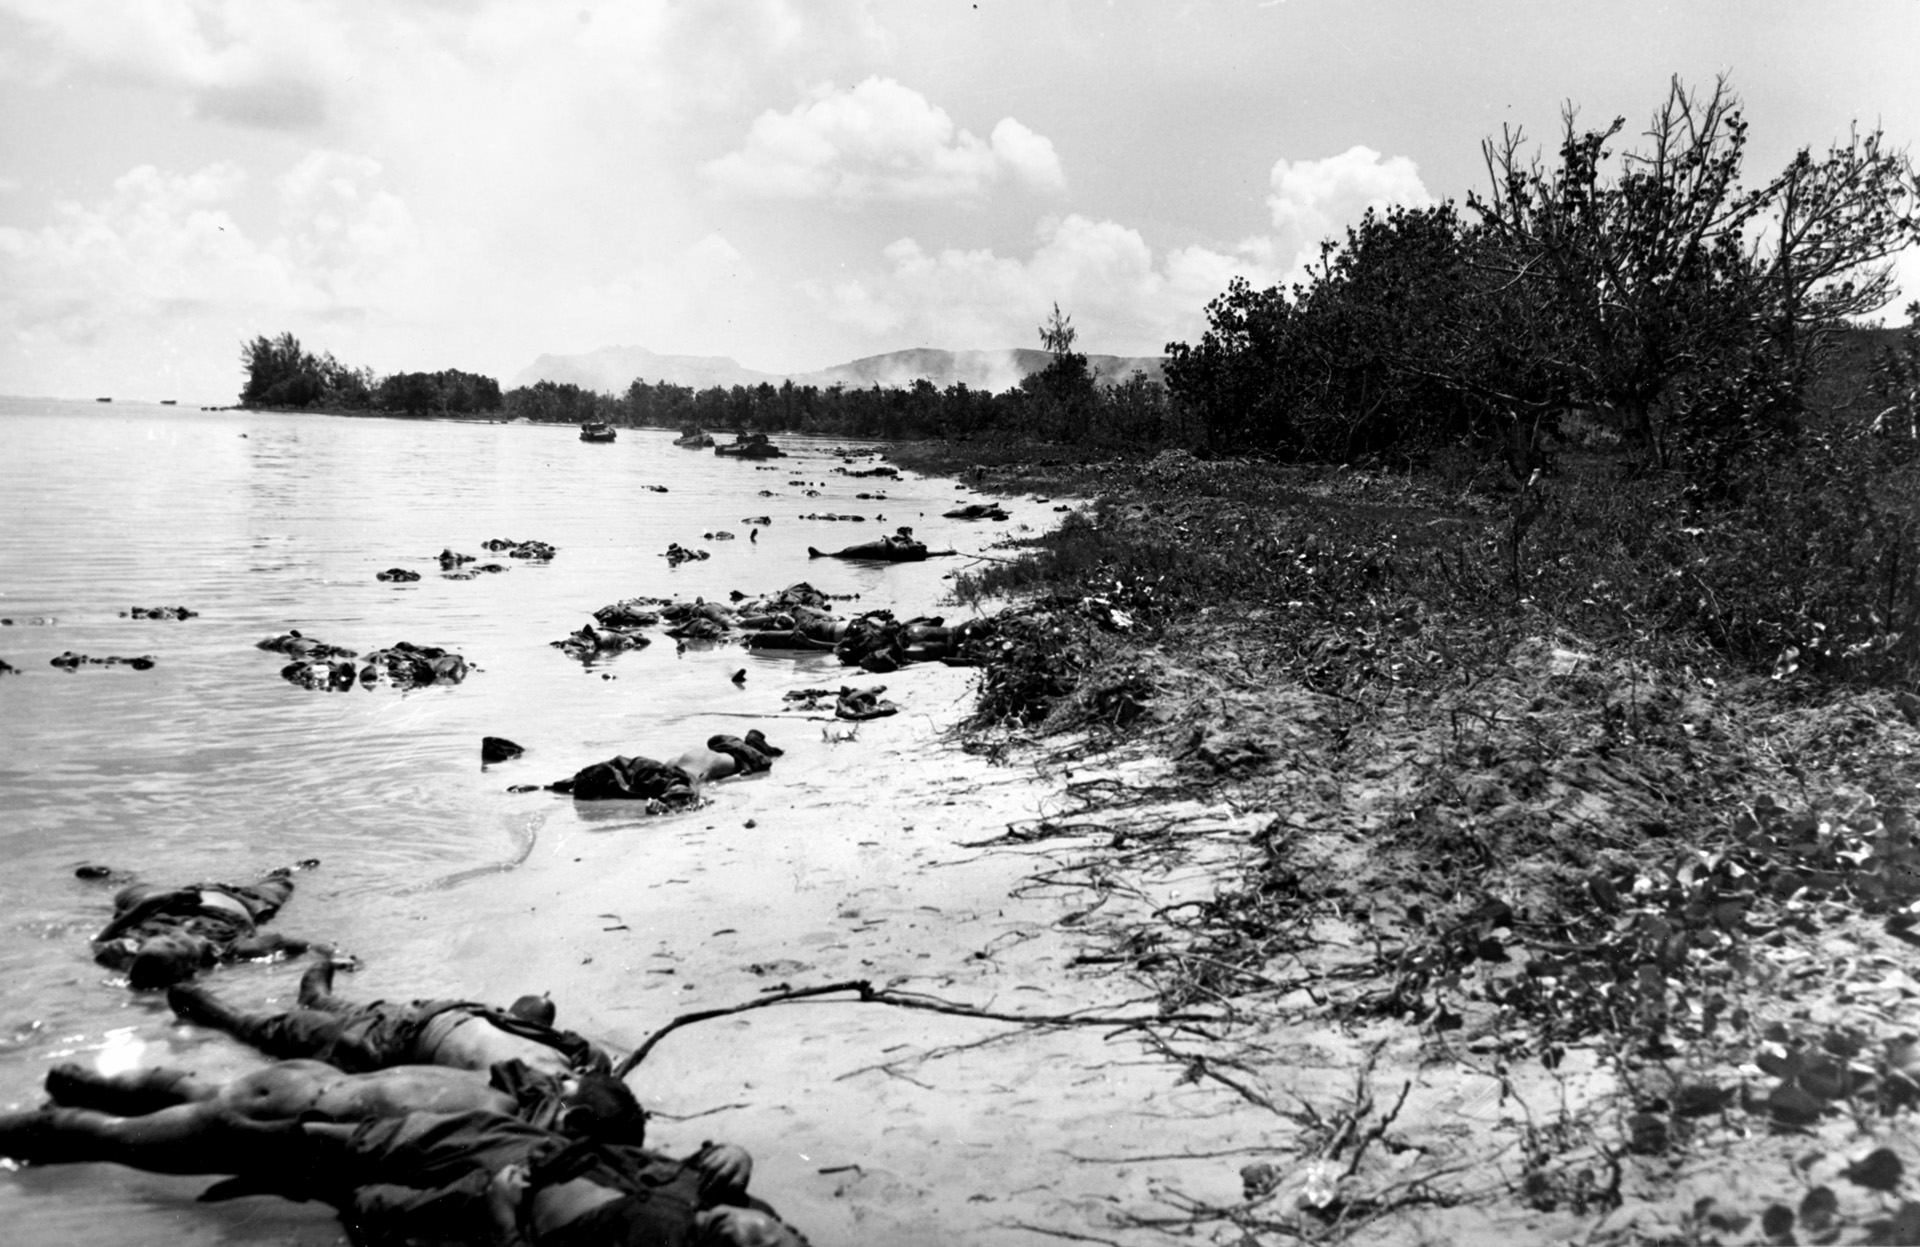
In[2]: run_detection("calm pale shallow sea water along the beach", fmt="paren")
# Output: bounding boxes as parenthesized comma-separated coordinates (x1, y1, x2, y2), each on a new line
(0, 398, 1021, 1247)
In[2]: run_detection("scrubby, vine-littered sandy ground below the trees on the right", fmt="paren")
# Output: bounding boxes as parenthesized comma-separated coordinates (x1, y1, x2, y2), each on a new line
(887, 447, 1920, 1245)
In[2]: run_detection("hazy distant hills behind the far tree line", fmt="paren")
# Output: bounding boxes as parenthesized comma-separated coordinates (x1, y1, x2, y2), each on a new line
(513, 346, 1164, 394)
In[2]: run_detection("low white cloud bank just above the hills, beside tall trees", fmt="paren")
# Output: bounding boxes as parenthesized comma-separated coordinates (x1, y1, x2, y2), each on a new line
(808, 215, 1277, 355)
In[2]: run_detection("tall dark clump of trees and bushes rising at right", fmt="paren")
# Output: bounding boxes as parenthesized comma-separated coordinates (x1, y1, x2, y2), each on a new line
(1167, 79, 1920, 482)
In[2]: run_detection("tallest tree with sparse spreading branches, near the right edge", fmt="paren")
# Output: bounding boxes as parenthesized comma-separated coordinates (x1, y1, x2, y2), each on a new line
(1469, 77, 1920, 465)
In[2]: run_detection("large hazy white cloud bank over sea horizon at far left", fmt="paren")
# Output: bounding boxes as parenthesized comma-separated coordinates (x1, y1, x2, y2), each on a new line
(0, 152, 444, 396)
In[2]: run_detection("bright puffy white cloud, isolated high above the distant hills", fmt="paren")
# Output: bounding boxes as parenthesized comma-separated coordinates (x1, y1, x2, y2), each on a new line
(701, 77, 1066, 204)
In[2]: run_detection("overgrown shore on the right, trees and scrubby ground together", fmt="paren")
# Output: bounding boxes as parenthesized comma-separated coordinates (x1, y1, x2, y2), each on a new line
(895, 86, 1920, 1243)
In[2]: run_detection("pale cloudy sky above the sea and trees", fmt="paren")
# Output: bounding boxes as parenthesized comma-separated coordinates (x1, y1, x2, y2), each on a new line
(0, 0, 1920, 403)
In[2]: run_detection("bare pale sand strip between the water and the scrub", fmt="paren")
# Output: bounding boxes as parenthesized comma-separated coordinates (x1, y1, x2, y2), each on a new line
(432, 667, 1258, 1245)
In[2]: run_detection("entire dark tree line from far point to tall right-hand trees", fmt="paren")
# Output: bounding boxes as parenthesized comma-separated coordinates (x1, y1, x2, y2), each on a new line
(242, 79, 1920, 478)
